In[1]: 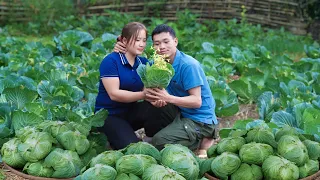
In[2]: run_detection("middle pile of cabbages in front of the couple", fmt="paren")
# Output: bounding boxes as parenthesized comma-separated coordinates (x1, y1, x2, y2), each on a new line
(76, 142, 205, 180)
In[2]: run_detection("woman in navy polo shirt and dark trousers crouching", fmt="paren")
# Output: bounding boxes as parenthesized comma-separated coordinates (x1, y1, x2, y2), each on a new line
(95, 22, 148, 149)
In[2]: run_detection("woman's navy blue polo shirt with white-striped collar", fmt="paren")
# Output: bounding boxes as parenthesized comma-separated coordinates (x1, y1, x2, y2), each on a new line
(95, 52, 148, 115)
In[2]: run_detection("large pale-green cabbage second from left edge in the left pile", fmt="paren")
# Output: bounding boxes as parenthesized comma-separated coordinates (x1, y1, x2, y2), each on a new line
(18, 132, 54, 162)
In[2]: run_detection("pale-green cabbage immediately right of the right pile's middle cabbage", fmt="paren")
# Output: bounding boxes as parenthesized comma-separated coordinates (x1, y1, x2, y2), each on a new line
(278, 135, 309, 166)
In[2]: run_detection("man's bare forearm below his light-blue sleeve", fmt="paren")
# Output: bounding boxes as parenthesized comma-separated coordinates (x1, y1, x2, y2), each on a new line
(166, 95, 202, 108)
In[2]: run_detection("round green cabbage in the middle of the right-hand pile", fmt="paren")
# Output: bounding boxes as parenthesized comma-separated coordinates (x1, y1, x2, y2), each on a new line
(239, 142, 273, 165)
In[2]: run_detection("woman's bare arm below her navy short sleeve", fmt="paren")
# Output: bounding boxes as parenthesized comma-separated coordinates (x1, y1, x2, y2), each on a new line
(102, 77, 145, 103)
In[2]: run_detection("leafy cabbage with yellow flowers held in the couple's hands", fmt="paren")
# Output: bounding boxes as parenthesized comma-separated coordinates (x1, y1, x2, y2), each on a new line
(137, 48, 174, 89)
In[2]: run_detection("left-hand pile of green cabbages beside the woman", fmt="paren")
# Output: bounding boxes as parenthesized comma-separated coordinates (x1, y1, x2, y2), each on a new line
(1, 121, 107, 178)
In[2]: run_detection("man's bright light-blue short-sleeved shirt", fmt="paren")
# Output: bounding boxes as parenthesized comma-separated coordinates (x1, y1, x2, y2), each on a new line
(167, 50, 218, 124)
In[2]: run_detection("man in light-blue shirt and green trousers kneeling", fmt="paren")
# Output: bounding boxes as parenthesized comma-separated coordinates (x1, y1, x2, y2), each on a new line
(115, 24, 218, 150)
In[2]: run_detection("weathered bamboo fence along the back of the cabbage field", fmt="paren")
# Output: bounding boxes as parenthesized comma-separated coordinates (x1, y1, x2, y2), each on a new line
(0, 0, 317, 34)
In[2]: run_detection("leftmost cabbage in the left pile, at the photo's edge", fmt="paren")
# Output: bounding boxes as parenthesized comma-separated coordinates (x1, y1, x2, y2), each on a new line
(1, 138, 27, 168)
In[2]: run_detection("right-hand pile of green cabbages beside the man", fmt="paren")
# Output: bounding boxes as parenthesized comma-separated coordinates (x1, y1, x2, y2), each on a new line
(200, 127, 320, 180)
